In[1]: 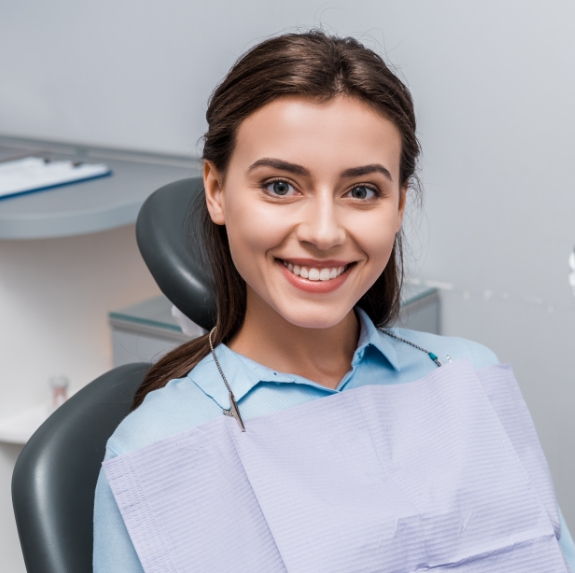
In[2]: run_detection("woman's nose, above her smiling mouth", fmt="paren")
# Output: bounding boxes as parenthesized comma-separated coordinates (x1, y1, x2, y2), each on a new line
(297, 190, 346, 251)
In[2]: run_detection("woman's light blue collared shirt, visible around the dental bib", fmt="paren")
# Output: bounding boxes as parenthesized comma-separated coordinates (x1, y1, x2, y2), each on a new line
(94, 309, 575, 573)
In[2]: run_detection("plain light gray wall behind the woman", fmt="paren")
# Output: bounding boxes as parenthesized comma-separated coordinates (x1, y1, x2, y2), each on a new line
(0, 0, 575, 568)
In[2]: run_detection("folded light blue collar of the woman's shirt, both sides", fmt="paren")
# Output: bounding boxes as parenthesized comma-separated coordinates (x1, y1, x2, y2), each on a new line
(188, 307, 399, 409)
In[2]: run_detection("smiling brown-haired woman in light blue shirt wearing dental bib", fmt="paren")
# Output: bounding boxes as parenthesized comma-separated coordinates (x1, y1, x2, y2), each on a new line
(94, 31, 573, 573)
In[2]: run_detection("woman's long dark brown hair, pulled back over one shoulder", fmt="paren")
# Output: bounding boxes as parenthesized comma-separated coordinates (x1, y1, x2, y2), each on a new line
(134, 30, 420, 408)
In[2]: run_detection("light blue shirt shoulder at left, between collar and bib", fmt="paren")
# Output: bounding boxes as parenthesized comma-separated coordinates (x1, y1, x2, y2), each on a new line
(107, 375, 221, 457)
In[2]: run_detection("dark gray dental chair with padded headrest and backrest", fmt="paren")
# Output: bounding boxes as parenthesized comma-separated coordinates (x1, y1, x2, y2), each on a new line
(12, 179, 209, 573)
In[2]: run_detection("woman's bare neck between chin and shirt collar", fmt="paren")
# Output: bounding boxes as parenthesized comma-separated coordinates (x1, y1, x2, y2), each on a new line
(228, 287, 359, 388)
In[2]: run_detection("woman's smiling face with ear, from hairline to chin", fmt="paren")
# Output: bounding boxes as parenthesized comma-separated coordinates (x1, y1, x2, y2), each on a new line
(204, 96, 405, 328)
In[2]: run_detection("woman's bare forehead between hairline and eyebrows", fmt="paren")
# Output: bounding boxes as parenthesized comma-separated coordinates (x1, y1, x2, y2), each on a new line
(230, 96, 401, 181)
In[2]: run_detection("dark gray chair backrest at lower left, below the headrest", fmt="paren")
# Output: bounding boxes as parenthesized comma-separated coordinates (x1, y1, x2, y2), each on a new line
(12, 363, 150, 573)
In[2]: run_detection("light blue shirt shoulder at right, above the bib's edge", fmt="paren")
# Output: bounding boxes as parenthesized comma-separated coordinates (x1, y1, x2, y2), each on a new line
(388, 328, 499, 368)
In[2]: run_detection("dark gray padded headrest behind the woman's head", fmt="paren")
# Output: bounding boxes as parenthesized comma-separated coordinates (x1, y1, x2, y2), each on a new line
(136, 178, 217, 330)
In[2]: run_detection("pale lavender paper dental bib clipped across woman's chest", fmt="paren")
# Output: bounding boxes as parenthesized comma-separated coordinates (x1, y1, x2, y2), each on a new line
(104, 360, 569, 573)
